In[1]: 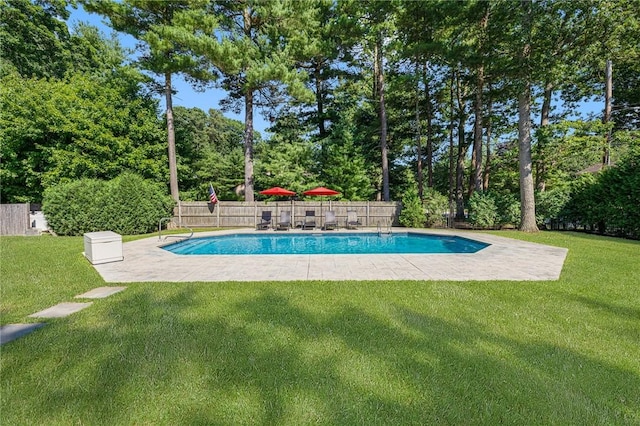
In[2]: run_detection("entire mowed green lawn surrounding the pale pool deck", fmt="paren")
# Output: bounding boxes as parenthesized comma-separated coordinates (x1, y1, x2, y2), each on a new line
(0, 232, 640, 425)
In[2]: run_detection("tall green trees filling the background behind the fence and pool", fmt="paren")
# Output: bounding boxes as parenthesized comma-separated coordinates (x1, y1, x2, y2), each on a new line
(0, 0, 640, 236)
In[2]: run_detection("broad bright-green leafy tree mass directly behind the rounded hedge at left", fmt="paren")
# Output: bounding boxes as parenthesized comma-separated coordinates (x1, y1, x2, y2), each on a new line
(0, 74, 166, 202)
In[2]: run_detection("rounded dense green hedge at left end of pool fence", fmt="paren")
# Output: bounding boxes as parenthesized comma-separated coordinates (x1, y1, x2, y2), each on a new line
(42, 173, 173, 235)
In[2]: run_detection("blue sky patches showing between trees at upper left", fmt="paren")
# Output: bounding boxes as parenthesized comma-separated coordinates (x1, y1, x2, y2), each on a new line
(68, 5, 269, 133)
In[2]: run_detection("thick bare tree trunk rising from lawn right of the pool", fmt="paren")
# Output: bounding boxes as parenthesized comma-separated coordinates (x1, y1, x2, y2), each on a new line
(518, 83, 538, 232)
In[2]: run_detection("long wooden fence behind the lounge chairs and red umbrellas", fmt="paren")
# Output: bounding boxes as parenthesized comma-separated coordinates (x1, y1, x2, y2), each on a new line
(173, 200, 402, 228)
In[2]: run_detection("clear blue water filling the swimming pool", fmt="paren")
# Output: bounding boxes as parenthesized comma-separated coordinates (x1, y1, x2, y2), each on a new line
(162, 232, 489, 255)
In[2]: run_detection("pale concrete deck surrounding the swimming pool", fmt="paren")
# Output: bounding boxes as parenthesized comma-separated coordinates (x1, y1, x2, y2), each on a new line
(94, 228, 568, 283)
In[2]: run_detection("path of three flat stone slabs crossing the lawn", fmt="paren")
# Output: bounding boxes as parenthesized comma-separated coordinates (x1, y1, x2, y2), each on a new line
(0, 287, 126, 345)
